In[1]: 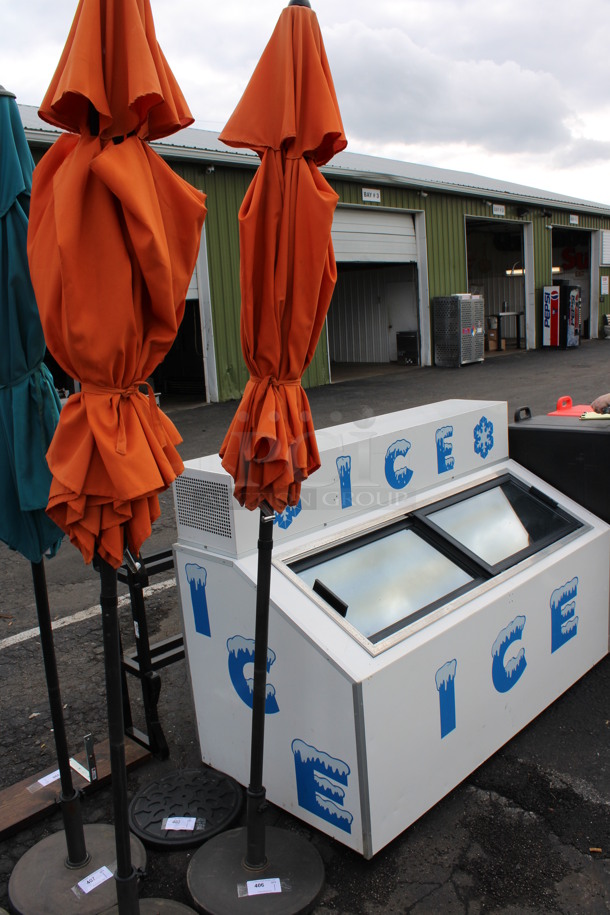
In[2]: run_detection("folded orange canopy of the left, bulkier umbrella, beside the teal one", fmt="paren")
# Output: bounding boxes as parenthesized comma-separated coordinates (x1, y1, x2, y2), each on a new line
(28, 0, 206, 568)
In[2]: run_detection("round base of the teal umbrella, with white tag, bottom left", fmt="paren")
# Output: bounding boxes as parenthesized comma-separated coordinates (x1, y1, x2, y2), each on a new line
(8, 824, 146, 915)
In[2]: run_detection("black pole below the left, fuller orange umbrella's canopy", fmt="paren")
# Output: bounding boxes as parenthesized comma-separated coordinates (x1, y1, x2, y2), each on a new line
(97, 557, 140, 915)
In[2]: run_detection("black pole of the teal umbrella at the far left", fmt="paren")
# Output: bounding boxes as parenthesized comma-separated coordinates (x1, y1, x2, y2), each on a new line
(32, 559, 89, 868)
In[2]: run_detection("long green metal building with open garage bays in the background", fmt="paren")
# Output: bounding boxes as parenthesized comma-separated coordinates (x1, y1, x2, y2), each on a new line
(20, 106, 610, 401)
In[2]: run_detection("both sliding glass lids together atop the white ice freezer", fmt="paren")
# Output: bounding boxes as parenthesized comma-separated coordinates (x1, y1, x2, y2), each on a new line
(289, 474, 583, 643)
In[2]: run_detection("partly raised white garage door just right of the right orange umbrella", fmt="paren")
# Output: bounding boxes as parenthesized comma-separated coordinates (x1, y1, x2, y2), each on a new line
(332, 207, 417, 264)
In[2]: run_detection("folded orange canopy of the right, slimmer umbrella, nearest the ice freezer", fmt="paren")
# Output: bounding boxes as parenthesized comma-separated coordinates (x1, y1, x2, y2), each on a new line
(220, 5, 347, 512)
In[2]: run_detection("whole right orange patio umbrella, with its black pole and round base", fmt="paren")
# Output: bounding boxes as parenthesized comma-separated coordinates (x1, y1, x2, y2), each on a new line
(187, 0, 347, 915)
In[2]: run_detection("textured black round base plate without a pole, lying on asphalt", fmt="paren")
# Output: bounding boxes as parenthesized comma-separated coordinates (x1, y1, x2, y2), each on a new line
(129, 769, 244, 849)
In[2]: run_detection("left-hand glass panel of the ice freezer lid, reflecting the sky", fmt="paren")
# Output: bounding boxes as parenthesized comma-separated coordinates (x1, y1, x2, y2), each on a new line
(298, 529, 473, 636)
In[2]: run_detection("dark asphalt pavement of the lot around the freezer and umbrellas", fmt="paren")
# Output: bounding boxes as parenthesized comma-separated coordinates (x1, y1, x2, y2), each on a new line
(0, 340, 610, 915)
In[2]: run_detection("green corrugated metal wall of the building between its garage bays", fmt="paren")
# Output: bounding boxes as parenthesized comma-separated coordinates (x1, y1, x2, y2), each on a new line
(172, 162, 610, 400)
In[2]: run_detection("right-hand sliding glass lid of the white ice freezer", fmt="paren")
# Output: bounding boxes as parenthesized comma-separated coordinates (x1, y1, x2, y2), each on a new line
(418, 476, 582, 574)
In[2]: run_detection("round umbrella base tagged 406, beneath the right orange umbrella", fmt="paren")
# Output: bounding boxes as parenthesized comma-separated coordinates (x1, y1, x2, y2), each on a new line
(186, 827, 324, 915)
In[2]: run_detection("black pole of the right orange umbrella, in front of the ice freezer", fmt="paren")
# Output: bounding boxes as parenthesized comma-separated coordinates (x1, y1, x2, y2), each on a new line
(245, 505, 274, 870)
